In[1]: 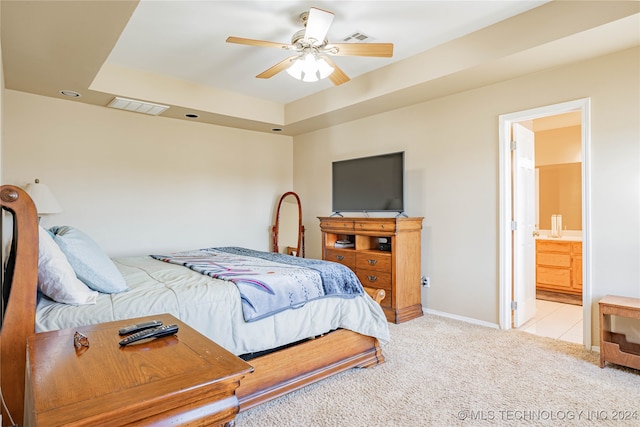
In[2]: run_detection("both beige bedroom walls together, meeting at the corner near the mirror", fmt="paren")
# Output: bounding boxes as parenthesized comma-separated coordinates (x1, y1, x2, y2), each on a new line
(3, 48, 640, 342)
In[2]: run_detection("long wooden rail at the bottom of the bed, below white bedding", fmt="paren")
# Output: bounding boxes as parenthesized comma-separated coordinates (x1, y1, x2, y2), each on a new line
(236, 329, 384, 411)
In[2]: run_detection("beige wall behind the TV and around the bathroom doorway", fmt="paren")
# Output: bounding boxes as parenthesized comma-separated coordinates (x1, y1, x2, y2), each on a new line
(294, 48, 640, 342)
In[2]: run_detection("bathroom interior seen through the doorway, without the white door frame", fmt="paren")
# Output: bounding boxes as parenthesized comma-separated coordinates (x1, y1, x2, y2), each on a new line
(512, 111, 583, 344)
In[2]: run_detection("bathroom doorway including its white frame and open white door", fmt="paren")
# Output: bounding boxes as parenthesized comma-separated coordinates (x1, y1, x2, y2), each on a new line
(500, 99, 591, 348)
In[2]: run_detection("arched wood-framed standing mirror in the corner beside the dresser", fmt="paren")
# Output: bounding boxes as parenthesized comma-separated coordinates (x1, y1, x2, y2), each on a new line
(272, 191, 304, 258)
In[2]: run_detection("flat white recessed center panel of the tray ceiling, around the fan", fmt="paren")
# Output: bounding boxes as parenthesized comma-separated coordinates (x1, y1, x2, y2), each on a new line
(107, 0, 547, 104)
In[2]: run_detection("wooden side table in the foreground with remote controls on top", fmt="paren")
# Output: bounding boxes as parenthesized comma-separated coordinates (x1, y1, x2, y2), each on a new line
(24, 314, 253, 426)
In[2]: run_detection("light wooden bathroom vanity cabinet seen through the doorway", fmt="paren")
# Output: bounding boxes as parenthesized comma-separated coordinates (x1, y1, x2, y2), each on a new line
(536, 239, 582, 295)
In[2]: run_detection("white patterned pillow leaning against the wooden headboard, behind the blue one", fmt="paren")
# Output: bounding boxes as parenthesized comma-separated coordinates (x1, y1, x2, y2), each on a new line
(38, 227, 98, 305)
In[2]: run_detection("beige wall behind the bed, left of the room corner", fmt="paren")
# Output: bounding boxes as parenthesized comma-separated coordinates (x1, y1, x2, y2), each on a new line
(2, 90, 293, 256)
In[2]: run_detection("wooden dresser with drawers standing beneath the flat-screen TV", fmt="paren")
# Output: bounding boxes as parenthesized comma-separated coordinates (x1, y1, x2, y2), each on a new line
(318, 217, 423, 323)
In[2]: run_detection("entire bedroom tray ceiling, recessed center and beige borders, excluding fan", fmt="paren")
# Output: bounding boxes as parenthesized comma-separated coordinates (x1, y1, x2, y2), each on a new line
(0, 0, 640, 136)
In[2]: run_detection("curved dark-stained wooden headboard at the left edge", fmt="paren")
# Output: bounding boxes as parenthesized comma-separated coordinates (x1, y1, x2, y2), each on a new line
(0, 185, 38, 425)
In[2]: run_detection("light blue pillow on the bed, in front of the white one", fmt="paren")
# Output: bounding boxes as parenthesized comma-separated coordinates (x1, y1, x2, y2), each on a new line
(49, 226, 128, 294)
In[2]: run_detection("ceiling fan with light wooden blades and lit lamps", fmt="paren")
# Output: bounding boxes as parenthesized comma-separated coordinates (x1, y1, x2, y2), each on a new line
(227, 7, 393, 86)
